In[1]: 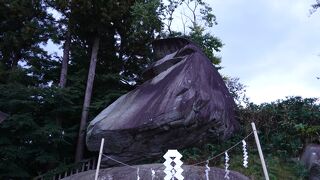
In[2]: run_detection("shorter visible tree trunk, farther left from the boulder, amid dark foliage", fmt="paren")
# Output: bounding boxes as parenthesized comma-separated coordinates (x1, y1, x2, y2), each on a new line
(59, 31, 71, 88)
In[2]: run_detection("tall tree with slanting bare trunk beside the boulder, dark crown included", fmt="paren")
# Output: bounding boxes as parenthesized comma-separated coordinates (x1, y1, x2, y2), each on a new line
(71, 0, 138, 161)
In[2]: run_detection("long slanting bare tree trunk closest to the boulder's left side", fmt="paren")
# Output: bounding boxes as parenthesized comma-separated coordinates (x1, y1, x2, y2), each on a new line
(75, 37, 100, 162)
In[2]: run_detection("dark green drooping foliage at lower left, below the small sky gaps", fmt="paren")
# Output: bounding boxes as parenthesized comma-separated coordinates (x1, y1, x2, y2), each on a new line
(0, 83, 79, 179)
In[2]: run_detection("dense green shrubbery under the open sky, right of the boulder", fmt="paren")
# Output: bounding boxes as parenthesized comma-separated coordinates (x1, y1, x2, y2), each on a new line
(239, 97, 320, 157)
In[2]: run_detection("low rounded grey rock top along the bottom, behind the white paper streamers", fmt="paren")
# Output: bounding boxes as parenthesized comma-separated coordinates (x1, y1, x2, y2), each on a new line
(63, 164, 249, 180)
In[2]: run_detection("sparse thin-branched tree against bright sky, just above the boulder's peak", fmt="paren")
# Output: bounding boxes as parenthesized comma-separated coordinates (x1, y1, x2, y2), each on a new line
(163, 0, 223, 69)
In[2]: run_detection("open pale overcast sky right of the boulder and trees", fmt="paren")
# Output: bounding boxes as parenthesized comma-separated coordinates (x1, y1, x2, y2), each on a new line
(210, 0, 320, 103)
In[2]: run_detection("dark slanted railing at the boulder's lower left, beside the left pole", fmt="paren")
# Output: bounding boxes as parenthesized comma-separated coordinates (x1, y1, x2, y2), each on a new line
(33, 158, 97, 180)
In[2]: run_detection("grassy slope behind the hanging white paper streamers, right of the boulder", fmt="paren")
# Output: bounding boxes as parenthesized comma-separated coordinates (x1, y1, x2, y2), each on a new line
(182, 144, 307, 180)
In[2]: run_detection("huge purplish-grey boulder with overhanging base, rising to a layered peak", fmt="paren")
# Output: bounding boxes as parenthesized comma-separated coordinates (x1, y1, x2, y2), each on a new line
(86, 38, 238, 165)
